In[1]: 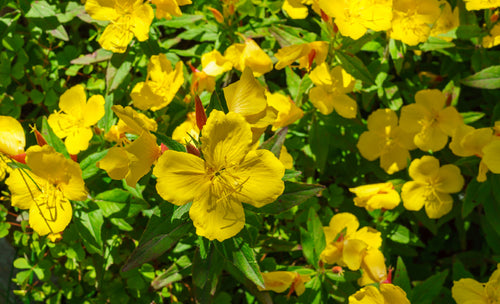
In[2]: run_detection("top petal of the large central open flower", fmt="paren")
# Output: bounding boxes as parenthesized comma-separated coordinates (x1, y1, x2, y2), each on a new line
(201, 110, 252, 167)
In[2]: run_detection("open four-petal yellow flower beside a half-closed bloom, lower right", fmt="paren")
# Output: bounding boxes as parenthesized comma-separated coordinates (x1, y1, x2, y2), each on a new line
(401, 156, 464, 219)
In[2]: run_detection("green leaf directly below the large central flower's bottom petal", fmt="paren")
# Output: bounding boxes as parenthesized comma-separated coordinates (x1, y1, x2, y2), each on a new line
(222, 237, 264, 288)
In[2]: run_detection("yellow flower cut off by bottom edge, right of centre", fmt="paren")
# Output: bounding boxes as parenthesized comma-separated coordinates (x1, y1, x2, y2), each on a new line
(349, 284, 410, 304)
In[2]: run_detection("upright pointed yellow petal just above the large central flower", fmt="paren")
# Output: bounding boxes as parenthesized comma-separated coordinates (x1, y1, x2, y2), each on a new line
(223, 68, 267, 116)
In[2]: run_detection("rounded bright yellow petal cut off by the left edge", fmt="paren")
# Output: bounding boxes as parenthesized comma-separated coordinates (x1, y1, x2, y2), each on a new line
(0, 116, 26, 155)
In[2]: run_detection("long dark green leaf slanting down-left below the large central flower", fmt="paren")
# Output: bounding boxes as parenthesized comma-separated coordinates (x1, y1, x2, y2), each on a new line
(122, 222, 193, 272)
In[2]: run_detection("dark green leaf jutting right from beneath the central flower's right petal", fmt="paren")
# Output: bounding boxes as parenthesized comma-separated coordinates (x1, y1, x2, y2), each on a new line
(249, 181, 325, 214)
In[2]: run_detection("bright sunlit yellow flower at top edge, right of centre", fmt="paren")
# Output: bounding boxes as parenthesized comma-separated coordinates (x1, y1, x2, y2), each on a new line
(318, 0, 392, 39)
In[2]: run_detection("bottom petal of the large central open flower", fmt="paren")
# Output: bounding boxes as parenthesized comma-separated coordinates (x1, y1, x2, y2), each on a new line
(189, 183, 245, 242)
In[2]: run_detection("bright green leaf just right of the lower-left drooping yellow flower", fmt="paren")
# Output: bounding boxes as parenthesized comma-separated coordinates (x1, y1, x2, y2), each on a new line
(74, 209, 104, 255)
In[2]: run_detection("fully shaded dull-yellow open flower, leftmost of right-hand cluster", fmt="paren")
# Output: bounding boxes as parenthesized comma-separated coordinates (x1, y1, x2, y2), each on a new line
(357, 109, 415, 174)
